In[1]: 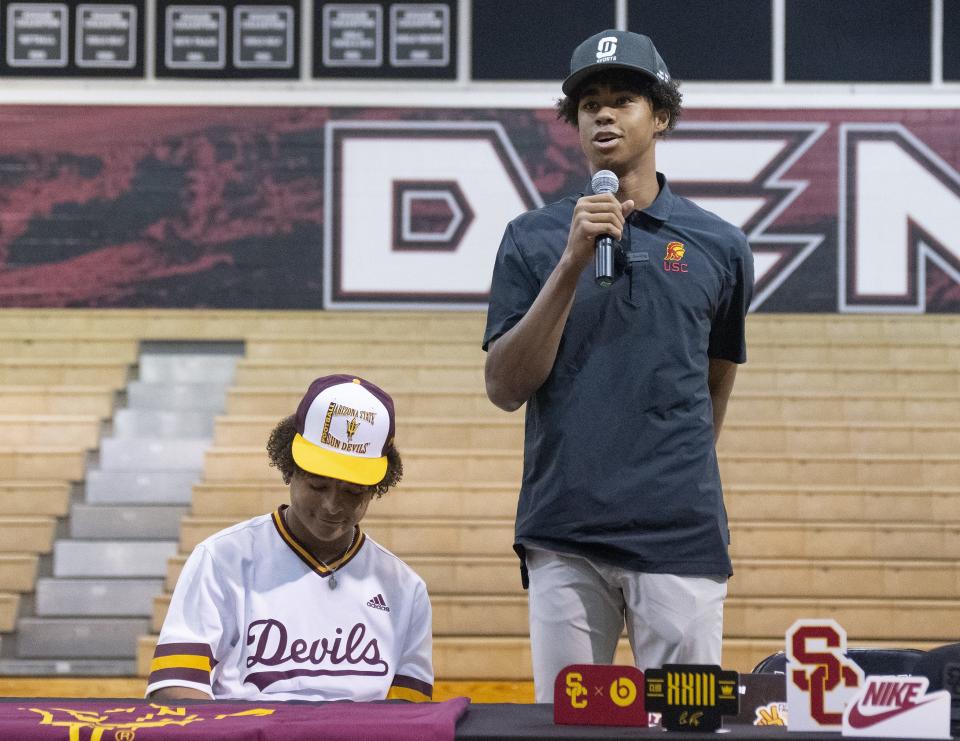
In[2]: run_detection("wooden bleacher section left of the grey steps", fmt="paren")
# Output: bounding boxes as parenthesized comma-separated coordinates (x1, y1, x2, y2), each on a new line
(0, 320, 136, 660)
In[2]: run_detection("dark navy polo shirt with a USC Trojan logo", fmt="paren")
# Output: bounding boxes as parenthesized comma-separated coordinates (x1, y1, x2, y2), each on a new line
(483, 173, 753, 581)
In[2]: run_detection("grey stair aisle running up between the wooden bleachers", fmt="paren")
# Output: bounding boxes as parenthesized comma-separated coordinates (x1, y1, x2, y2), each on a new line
(7, 346, 239, 673)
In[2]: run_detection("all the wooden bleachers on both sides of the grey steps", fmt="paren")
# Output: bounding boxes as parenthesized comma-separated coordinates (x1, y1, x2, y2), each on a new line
(0, 310, 960, 680)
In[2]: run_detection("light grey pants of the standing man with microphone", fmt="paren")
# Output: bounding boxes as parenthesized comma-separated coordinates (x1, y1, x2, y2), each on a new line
(526, 548, 727, 703)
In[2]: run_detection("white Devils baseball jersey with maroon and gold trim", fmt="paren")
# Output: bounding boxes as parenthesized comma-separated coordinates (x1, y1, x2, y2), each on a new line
(147, 505, 433, 701)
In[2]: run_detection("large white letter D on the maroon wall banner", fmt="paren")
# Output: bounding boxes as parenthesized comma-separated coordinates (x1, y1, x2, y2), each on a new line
(324, 121, 542, 308)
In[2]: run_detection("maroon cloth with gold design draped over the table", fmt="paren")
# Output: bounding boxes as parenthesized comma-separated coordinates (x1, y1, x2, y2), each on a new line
(0, 697, 470, 741)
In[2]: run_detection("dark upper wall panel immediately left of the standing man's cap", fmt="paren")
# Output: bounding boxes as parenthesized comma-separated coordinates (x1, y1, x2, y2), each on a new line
(472, 0, 616, 80)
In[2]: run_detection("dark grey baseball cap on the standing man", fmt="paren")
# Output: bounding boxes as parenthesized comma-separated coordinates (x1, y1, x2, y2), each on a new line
(561, 29, 670, 95)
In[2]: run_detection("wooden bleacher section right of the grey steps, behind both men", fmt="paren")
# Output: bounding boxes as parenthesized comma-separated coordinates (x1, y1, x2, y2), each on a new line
(129, 315, 960, 680)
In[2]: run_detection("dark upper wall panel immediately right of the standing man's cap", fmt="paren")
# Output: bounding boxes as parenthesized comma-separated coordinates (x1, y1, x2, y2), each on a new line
(627, 0, 776, 82)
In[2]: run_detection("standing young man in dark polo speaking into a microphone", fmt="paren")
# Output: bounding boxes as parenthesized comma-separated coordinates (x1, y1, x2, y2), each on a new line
(483, 30, 753, 702)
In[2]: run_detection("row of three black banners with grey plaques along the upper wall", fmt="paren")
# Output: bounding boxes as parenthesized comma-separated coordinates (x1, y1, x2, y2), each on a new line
(0, 0, 456, 79)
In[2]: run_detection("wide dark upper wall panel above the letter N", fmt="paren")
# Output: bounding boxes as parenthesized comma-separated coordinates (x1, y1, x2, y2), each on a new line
(785, 0, 931, 83)
